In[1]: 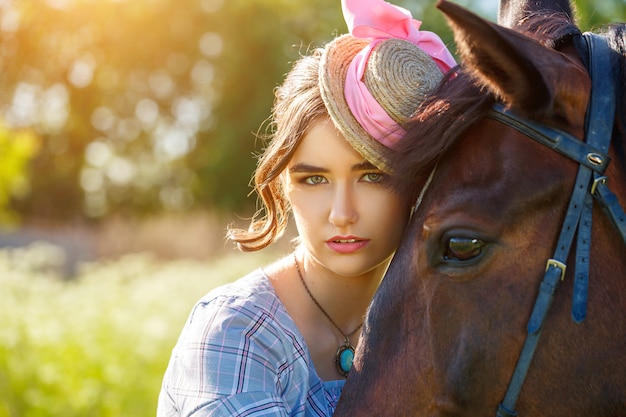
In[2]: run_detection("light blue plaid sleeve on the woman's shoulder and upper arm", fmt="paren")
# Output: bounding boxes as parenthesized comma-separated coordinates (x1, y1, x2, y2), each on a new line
(157, 297, 299, 417)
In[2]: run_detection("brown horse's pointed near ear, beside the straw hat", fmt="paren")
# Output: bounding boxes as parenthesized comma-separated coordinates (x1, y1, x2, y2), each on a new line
(437, 0, 589, 124)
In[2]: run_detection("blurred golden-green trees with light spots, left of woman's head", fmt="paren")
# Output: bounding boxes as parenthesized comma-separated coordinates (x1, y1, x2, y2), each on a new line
(0, 0, 343, 220)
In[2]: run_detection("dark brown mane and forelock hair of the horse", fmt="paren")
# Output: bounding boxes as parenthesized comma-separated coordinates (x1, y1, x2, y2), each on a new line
(392, 15, 626, 192)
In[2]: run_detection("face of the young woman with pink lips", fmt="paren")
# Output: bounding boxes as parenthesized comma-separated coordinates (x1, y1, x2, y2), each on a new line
(285, 118, 410, 276)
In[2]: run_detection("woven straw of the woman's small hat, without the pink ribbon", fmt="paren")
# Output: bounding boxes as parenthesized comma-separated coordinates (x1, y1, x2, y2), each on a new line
(319, 35, 443, 172)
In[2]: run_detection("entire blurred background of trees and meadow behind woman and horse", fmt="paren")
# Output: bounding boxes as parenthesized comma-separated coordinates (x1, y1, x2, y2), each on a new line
(0, 0, 626, 417)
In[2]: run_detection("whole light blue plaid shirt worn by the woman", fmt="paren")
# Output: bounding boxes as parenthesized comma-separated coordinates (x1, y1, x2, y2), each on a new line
(157, 269, 345, 417)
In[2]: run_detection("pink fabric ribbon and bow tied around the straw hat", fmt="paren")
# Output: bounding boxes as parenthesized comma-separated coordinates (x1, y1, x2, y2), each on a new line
(341, 0, 456, 147)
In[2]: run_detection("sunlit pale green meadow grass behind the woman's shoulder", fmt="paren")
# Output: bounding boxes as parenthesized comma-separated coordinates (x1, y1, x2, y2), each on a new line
(0, 244, 276, 417)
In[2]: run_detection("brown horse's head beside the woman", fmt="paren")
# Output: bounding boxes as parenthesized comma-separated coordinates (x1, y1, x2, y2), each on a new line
(335, 1, 626, 417)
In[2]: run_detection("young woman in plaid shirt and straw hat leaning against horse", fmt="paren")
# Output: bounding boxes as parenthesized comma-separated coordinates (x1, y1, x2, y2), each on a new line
(158, 0, 455, 416)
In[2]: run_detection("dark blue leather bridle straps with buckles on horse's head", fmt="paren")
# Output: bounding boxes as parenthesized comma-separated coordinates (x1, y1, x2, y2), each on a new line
(487, 33, 626, 417)
